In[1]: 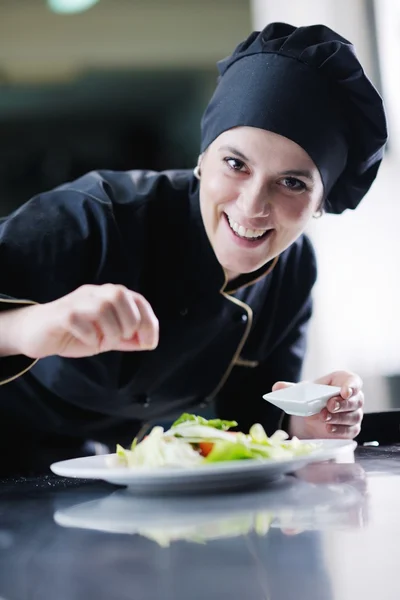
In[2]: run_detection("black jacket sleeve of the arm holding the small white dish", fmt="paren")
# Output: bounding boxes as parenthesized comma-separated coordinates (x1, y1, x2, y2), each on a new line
(216, 239, 316, 435)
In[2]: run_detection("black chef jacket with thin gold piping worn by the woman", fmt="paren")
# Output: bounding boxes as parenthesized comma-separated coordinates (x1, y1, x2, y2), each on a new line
(0, 171, 316, 470)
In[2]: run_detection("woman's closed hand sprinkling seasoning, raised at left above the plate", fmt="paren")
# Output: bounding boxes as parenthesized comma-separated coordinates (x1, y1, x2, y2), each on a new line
(8, 284, 159, 358)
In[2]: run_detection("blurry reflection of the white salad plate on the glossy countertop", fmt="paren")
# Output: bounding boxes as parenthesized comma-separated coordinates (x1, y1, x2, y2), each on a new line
(54, 464, 365, 547)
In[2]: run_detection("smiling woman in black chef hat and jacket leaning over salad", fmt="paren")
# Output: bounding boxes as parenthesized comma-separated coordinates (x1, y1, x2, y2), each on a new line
(0, 23, 386, 472)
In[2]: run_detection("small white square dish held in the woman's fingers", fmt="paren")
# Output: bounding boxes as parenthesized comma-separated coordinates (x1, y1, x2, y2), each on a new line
(263, 382, 340, 417)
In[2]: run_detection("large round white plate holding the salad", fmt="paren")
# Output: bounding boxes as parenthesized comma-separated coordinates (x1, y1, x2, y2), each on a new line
(50, 440, 357, 494)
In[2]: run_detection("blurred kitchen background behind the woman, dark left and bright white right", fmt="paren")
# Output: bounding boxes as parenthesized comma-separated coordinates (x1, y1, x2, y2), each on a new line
(0, 0, 400, 411)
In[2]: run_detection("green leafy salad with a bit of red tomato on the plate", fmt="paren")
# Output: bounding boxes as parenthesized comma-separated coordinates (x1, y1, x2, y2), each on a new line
(110, 413, 317, 468)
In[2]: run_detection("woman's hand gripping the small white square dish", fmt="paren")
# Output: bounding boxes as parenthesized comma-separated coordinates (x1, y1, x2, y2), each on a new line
(272, 371, 364, 439)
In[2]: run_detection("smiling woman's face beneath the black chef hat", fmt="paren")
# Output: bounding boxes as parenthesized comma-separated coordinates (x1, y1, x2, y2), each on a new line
(200, 127, 323, 279)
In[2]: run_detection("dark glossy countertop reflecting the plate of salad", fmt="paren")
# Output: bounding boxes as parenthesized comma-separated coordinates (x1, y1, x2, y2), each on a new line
(0, 446, 400, 600)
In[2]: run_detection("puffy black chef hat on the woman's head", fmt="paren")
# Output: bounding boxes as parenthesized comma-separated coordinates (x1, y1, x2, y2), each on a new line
(201, 23, 387, 213)
